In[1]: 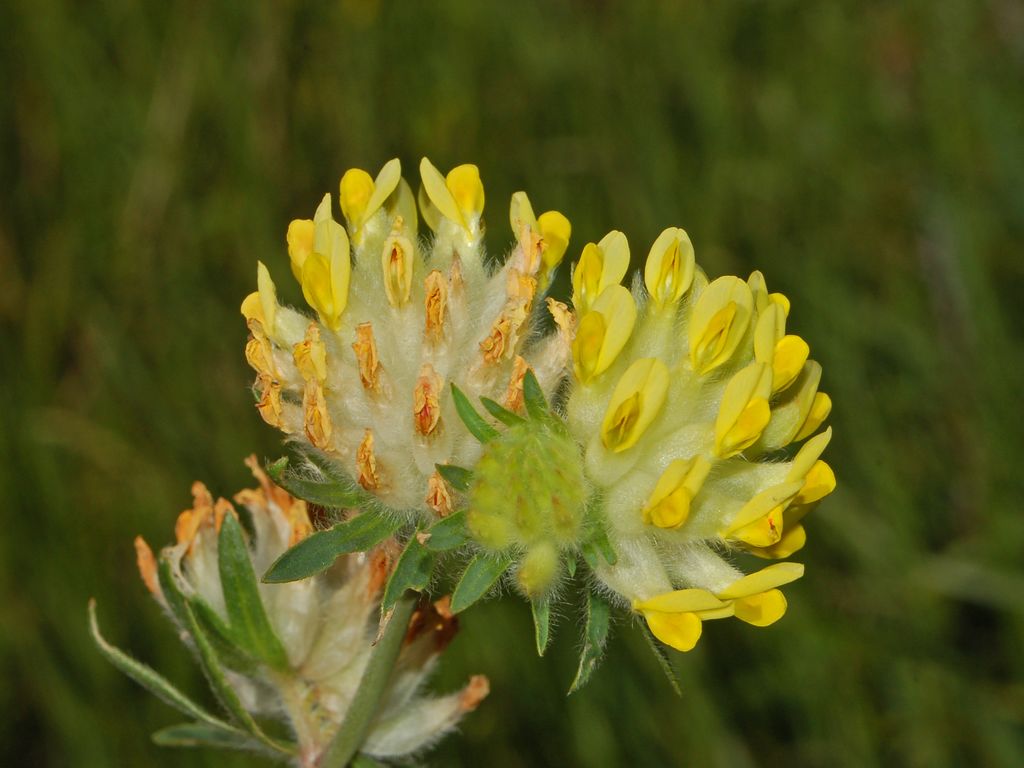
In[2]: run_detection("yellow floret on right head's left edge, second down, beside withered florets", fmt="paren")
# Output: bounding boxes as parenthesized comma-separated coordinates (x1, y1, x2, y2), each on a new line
(572, 285, 637, 384)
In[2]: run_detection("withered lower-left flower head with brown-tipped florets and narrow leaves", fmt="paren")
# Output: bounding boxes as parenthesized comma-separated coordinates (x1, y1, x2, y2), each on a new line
(89, 457, 488, 768)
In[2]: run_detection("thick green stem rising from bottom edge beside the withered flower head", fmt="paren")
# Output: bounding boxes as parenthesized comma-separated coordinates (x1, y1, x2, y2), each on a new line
(319, 591, 420, 768)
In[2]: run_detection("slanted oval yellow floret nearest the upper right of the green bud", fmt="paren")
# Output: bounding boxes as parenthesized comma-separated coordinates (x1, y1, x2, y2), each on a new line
(601, 357, 669, 454)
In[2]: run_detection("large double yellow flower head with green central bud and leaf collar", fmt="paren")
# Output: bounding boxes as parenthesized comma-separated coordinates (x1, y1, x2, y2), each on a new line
(242, 159, 835, 671)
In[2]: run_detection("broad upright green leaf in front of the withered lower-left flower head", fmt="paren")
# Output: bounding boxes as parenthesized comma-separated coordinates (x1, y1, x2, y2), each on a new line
(217, 515, 288, 670)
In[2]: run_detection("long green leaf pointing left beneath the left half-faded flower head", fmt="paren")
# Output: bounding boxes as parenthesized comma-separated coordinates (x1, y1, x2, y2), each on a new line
(263, 512, 401, 584)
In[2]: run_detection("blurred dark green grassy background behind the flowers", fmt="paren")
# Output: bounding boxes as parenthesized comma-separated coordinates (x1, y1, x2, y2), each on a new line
(0, 0, 1024, 768)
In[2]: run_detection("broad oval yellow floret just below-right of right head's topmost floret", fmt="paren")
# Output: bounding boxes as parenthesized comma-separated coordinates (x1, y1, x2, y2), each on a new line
(689, 275, 754, 374)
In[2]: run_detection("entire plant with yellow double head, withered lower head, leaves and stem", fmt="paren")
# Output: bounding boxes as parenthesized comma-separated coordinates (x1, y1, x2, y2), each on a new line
(97, 159, 836, 768)
